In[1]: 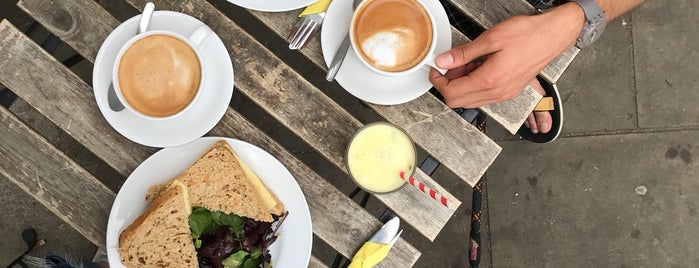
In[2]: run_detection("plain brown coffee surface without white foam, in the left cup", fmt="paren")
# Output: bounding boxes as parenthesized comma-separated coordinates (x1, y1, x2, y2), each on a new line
(118, 34, 201, 117)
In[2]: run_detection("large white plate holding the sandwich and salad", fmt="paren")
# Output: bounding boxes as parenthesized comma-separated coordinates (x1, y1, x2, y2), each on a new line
(107, 137, 313, 268)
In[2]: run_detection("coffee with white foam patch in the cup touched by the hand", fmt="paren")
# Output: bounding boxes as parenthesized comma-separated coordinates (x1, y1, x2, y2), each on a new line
(352, 0, 432, 72)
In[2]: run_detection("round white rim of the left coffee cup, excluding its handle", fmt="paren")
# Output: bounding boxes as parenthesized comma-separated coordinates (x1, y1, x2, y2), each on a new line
(112, 30, 208, 120)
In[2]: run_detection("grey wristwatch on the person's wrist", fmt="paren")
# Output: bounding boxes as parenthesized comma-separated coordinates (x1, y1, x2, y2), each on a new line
(570, 0, 607, 49)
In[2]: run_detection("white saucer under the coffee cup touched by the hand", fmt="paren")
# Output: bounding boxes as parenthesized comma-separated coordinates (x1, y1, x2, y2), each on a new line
(320, 0, 451, 105)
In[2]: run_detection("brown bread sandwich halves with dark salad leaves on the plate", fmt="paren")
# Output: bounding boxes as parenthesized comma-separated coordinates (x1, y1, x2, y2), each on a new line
(119, 141, 287, 267)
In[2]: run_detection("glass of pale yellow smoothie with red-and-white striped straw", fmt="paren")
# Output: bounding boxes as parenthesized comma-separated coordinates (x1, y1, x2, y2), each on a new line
(345, 122, 417, 193)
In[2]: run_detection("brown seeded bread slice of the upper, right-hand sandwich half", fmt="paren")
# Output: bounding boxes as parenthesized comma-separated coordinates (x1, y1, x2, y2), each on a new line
(146, 141, 273, 222)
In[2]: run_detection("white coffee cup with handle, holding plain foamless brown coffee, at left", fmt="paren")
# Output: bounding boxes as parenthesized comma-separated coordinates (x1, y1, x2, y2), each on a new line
(112, 25, 214, 120)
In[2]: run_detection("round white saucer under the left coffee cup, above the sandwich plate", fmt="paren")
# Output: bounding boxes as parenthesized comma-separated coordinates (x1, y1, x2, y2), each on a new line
(92, 10, 233, 147)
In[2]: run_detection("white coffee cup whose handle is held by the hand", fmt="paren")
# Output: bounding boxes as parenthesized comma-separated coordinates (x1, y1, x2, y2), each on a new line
(349, 0, 446, 76)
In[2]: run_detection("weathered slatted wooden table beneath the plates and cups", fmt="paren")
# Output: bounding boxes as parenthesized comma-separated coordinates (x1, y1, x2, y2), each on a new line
(0, 0, 577, 267)
